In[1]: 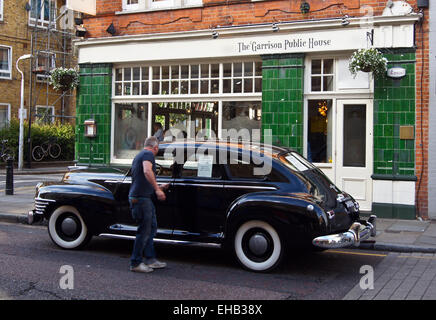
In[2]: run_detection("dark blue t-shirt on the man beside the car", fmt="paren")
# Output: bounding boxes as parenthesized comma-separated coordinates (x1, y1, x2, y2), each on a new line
(129, 149, 156, 198)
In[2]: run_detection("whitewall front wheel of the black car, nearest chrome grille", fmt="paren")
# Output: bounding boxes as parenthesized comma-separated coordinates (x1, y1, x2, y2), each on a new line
(48, 206, 91, 249)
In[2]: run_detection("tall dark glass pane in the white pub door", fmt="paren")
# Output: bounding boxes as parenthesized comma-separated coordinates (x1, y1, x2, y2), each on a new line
(343, 104, 366, 167)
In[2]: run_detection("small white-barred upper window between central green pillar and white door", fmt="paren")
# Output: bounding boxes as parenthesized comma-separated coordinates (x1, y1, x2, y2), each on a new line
(310, 59, 334, 92)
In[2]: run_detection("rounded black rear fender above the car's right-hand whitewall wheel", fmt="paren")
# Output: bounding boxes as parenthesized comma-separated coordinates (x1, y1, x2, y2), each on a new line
(224, 192, 328, 244)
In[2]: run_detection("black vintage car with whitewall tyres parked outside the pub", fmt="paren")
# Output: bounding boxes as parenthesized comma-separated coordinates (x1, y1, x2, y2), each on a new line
(28, 141, 376, 271)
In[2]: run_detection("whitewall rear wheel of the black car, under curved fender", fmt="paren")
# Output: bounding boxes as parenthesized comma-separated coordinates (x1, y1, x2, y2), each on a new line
(234, 220, 283, 271)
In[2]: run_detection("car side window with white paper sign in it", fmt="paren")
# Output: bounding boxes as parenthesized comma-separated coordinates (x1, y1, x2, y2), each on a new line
(181, 155, 221, 179)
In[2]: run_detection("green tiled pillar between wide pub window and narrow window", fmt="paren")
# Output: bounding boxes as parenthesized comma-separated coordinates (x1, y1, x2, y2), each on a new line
(262, 54, 304, 153)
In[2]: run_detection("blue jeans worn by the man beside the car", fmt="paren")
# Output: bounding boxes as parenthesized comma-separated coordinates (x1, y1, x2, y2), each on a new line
(129, 198, 157, 267)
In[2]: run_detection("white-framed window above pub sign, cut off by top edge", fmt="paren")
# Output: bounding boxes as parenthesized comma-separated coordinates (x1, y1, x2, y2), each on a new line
(122, 0, 203, 11)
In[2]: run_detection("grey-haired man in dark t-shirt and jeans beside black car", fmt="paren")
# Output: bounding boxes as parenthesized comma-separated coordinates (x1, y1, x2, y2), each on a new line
(129, 137, 167, 272)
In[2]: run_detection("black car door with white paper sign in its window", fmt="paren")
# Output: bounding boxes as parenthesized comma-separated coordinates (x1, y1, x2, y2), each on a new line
(174, 148, 226, 242)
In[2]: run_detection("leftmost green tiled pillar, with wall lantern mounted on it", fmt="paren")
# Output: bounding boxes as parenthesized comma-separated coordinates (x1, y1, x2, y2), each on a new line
(76, 64, 112, 164)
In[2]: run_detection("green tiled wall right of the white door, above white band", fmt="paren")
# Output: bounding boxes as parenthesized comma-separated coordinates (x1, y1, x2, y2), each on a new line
(374, 52, 415, 177)
